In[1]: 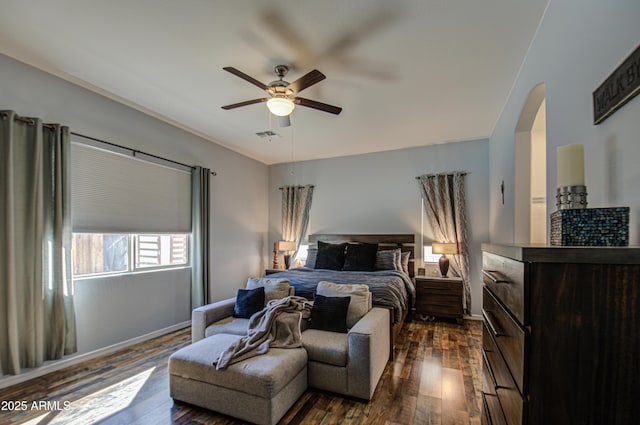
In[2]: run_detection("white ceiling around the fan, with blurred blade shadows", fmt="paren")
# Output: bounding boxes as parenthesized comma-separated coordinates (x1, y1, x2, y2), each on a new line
(0, 0, 548, 164)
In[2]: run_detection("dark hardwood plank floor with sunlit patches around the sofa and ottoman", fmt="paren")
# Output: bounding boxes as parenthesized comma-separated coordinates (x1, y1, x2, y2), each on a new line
(0, 320, 482, 425)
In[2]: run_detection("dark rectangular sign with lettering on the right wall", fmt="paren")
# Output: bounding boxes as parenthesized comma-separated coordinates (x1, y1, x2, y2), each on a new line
(593, 46, 640, 125)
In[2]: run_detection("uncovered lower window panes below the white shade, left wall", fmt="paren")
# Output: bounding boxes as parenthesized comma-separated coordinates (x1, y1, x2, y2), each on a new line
(72, 233, 189, 277)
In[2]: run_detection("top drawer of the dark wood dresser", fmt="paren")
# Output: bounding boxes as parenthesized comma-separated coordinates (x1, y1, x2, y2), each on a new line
(482, 252, 530, 326)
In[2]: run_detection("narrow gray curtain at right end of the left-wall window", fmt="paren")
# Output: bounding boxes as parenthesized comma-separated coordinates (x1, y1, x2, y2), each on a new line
(191, 167, 211, 309)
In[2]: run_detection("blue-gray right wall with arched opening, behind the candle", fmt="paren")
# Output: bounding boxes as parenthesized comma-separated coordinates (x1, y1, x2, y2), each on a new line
(490, 0, 640, 245)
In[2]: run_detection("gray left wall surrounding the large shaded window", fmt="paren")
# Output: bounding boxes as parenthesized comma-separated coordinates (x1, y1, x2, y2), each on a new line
(0, 55, 268, 352)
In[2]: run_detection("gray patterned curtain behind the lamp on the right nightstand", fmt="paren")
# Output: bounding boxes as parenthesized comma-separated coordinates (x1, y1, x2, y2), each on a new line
(418, 172, 471, 314)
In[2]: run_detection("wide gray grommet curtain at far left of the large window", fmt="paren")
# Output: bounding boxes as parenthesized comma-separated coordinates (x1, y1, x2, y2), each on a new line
(0, 111, 77, 374)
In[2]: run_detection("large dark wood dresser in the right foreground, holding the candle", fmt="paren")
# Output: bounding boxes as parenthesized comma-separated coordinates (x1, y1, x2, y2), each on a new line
(482, 244, 640, 425)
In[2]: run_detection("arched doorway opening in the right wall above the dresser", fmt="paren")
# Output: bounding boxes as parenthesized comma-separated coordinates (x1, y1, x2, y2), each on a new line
(514, 83, 547, 244)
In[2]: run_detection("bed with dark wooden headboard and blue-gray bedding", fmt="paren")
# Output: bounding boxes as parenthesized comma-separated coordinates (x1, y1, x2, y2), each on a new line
(269, 234, 415, 346)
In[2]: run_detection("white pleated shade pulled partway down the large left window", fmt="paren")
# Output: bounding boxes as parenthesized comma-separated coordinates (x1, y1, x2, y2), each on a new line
(71, 143, 191, 233)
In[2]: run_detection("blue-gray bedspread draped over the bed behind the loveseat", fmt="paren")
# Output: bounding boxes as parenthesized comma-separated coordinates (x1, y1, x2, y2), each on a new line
(268, 267, 415, 323)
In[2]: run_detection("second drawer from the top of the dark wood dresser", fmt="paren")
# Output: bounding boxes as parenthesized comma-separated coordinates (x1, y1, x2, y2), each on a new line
(482, 287, 528, 394)
